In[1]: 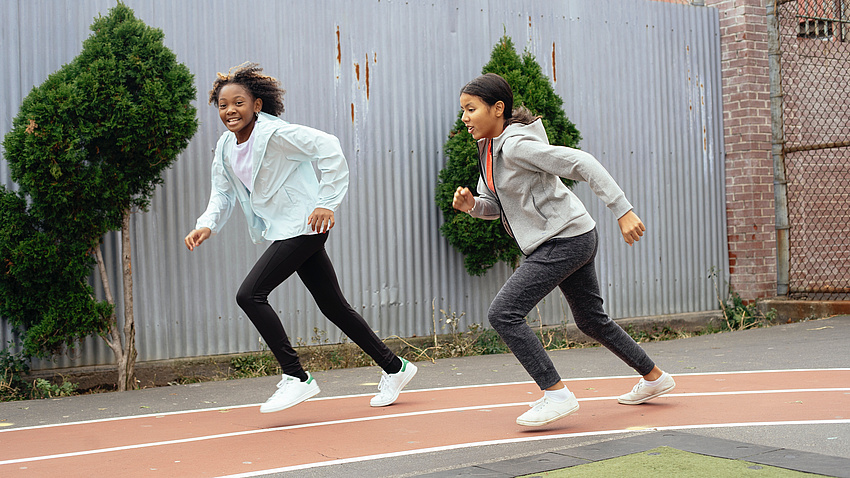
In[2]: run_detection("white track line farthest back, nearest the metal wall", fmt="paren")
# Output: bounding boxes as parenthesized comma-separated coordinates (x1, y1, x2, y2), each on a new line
(0, 368, 850, 434)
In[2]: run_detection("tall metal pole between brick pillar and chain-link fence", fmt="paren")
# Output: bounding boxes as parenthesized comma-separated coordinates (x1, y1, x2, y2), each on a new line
(767, 0, 791, 296)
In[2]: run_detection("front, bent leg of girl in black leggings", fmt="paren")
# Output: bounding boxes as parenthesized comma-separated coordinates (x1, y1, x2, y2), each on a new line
(236, 236, 321, 380)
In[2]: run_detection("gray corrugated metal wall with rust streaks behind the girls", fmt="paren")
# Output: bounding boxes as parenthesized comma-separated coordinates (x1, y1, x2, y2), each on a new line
(0, 0, 728, 367)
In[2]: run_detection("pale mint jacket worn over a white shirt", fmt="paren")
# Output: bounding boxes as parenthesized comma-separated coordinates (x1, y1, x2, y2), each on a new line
(195, 113, 348, 243)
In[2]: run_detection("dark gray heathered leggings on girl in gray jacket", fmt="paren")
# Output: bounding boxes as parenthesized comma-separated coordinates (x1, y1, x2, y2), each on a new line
(487, 229, 655, 390)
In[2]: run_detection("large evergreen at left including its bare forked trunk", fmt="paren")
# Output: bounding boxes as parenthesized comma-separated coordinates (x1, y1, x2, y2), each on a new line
(0, 2, 198, 389)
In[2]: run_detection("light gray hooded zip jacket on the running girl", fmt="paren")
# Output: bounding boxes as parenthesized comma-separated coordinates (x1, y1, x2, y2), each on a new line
(469, 120, 632, 255)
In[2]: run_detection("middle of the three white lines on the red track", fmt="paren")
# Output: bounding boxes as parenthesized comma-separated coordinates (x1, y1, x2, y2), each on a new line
(0, 388, 850, 466)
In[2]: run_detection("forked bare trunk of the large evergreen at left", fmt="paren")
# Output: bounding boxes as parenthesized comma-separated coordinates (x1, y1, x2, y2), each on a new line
(95, 210, 137, 391)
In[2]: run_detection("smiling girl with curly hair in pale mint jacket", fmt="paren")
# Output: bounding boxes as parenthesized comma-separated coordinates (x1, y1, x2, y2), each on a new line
(184, 63, 416, 413)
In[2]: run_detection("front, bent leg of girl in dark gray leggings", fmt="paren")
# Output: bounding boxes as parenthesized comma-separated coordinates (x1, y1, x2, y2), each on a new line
(488, 236, 600, 390)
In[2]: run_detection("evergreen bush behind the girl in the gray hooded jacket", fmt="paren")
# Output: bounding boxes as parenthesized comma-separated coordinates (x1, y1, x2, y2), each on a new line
(436, 36, 581, 276)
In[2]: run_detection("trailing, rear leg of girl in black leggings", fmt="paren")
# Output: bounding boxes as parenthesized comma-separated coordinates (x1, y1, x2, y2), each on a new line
(298, 234, 402, 373)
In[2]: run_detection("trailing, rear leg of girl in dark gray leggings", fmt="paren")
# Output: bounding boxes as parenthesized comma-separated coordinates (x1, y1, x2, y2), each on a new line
(559, 229, 660, 378)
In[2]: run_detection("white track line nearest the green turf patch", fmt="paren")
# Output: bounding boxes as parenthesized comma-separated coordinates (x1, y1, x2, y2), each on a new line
(210, 419, 850, 478)
